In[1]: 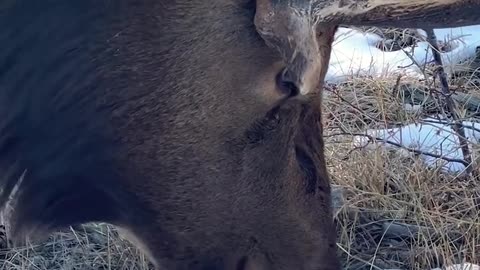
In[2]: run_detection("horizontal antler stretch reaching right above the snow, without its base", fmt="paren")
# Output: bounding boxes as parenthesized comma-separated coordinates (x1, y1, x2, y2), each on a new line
(314, 0, 480, 28)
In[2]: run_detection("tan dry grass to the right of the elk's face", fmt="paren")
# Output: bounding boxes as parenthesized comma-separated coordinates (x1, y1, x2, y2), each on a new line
(324, 73, 480, 270)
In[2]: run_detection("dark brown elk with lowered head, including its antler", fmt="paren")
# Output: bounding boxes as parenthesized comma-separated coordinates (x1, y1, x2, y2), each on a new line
(0, 0, 480, 270)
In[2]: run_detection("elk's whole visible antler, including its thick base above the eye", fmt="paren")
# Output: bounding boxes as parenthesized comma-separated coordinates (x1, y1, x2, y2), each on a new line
(255, 0, 480, 94)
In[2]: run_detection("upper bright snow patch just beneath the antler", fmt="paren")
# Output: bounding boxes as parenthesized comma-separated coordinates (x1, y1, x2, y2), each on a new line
(326, 25, 480, 82)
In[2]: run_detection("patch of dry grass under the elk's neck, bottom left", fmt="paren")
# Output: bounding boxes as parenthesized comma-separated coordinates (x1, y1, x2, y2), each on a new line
(0, 224, 153, 270)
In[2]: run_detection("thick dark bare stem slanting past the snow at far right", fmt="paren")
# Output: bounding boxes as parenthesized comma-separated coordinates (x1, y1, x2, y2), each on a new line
(425, 29, 477, 178)
